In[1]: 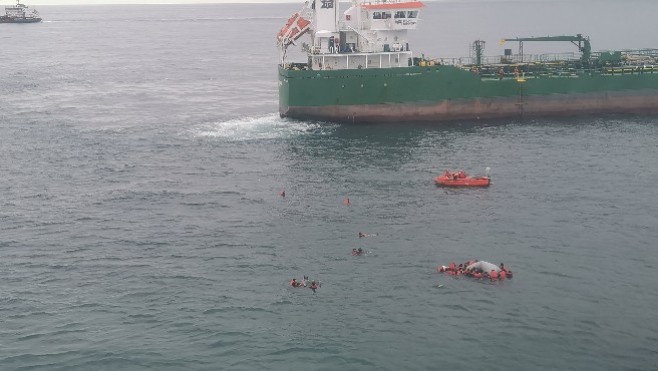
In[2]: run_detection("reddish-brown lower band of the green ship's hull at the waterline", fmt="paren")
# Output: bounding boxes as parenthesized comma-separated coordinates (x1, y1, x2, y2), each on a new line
(280, 91, 658, 123)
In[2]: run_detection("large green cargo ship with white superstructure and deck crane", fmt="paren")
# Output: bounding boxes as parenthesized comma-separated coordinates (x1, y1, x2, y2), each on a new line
(277, 0, 658, 123)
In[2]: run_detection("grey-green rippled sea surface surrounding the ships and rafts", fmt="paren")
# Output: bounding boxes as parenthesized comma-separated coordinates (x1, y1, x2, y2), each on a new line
(0, 1, 658, 370)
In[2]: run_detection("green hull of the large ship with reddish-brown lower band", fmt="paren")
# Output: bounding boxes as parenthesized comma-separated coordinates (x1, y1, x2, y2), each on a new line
(279, 65, 658, 123)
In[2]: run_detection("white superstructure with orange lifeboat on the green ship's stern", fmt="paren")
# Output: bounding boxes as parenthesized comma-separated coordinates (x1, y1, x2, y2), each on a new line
(277, 0, 424, 70)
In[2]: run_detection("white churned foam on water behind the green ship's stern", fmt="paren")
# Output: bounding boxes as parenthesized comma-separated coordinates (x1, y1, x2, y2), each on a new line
(192, 113, 335, 141)
